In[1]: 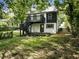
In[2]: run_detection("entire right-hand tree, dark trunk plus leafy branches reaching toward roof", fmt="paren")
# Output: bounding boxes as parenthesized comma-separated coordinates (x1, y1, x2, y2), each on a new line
(55, 0, 79, 37)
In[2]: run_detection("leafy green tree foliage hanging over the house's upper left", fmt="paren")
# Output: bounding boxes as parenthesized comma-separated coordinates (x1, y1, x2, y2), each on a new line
(5, 0, 48, 22)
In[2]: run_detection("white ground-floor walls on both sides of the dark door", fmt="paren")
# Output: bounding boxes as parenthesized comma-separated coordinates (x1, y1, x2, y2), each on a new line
(31, 23, 57, 33)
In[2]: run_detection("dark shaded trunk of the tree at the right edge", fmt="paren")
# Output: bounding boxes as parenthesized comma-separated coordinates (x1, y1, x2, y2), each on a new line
(67, 0, 79, 37)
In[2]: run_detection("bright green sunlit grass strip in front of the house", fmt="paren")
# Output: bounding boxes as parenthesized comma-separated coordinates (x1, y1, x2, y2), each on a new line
(0, 36, 60, 49)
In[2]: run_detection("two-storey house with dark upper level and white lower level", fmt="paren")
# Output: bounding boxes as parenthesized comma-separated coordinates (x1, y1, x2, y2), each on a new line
(19, 6, 58, 34)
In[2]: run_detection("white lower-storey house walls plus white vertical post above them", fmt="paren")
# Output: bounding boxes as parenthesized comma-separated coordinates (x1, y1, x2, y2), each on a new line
(31, 13, 58, 33)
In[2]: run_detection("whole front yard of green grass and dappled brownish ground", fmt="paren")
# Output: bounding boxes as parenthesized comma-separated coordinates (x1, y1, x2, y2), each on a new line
(0, 33, 79, 59)
